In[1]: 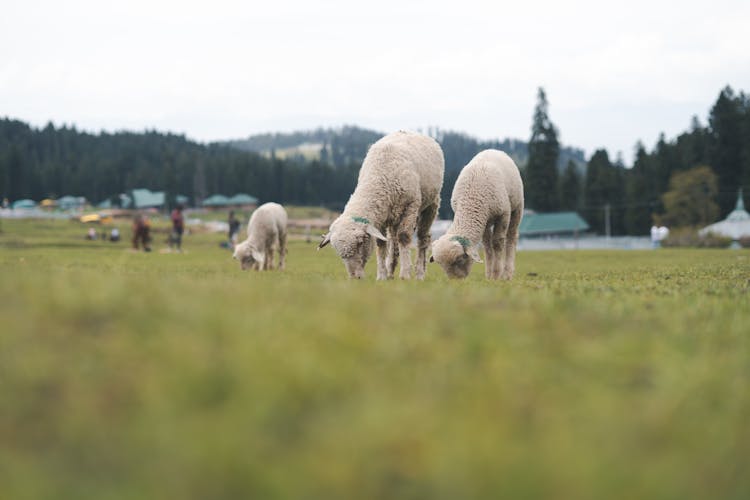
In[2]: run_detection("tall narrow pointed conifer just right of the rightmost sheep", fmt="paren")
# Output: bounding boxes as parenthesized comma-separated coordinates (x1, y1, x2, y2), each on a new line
(525, 87, 560, 212)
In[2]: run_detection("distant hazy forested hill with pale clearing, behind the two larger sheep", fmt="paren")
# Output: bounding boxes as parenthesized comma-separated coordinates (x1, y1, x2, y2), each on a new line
(226, 125, 586, 173)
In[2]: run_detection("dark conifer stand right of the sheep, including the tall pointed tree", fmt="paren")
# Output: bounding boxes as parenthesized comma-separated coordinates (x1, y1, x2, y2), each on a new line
(523, 86, 750, 235)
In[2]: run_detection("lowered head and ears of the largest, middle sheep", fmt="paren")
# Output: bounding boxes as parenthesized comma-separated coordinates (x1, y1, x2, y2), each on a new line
(318, 215, 386, 279)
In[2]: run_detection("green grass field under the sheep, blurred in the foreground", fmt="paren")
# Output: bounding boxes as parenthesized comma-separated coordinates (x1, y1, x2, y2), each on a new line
(0, 220, 750, 500)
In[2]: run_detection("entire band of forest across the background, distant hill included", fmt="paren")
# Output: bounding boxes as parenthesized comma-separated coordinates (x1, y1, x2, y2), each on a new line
(0, 87, 750, 235)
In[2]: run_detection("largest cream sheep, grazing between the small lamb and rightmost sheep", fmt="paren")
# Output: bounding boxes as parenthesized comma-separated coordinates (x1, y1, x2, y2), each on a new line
(318, 131, 445, 280)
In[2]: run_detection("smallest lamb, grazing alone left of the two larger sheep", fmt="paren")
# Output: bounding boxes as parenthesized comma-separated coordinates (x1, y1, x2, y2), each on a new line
(232, 203, 287, 271)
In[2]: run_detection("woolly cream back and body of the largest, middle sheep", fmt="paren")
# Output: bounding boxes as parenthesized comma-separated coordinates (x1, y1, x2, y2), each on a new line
(344, 132, 445, 226)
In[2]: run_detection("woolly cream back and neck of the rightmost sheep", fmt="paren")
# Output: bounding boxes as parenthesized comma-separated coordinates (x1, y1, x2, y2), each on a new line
(446, 149, 523, 245)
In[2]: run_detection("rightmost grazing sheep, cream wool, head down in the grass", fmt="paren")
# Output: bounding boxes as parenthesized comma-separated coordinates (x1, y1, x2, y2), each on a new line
(430, 149, 523, 280)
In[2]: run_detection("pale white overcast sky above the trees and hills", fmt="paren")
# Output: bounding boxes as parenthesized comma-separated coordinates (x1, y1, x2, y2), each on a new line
(0, 0, 750, 162)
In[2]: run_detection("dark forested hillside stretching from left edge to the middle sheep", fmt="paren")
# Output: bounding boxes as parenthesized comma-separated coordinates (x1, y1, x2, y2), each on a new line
(0, 118, 359, 208)
